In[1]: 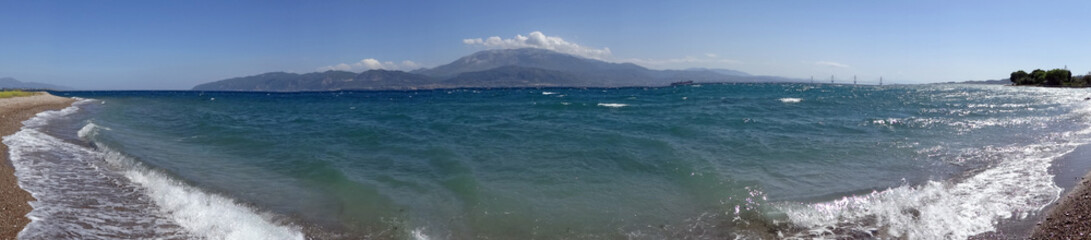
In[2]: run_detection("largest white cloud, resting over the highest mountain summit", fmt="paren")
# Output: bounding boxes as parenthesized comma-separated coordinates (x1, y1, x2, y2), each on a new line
(463, 31, 612, 60)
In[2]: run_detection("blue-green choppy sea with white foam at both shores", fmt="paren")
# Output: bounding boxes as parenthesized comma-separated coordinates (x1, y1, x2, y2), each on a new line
(3, 84, 1091, 239)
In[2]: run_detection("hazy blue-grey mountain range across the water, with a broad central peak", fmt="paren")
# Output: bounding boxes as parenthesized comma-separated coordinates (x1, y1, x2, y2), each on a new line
(193, 48, 802, 92)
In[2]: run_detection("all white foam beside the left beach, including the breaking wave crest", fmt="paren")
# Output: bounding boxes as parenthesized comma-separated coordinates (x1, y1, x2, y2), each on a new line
(3, 105, 304, 239)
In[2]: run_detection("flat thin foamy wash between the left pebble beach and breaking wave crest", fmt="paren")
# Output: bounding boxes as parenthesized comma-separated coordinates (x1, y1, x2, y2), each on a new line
(3, 129, 193, 239)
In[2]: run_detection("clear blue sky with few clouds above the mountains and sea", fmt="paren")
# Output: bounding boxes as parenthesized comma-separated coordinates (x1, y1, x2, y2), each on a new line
(0, 0, 1091, 89)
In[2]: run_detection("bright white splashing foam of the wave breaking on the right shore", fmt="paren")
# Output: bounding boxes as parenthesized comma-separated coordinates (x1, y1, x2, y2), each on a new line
(780, 123, 1082, 239)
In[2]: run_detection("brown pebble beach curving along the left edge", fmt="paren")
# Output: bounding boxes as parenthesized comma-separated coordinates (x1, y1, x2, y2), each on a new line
(0, 93, 75, 239)
